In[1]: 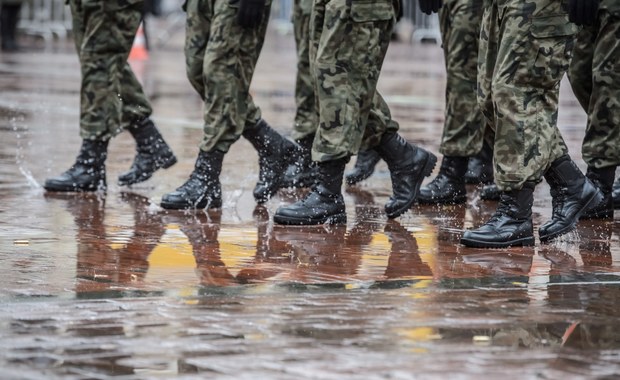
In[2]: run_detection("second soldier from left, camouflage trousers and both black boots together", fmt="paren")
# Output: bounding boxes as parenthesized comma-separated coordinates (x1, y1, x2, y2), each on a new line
(162, 0, 295, 208)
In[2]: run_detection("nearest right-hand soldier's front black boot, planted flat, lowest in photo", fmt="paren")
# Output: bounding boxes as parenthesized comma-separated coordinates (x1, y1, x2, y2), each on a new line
(461, 182, 536, 248)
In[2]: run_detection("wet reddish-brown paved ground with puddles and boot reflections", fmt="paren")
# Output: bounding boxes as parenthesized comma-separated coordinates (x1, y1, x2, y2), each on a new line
(0, 19, 620, 379)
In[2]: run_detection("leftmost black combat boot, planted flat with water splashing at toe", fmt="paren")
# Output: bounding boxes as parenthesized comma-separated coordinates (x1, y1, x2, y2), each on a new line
(43, 140, 109, 191)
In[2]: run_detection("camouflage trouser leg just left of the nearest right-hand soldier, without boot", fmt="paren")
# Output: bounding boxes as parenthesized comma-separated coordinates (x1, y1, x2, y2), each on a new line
(439, 0, 485, 157)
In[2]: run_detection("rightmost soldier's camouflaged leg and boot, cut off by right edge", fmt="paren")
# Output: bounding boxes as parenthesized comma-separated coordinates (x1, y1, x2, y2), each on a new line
(571, 9, 620, 219)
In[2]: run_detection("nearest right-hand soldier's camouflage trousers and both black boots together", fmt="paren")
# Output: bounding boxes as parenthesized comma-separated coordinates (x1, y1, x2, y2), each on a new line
(462, 0, 600, 247)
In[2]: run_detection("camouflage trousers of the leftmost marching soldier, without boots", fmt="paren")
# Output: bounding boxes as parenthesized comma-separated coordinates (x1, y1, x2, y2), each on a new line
(69, 0, 152, 140)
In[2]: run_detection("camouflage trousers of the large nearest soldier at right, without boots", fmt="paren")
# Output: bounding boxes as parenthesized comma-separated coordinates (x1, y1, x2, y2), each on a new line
(478, 0, 577, 191)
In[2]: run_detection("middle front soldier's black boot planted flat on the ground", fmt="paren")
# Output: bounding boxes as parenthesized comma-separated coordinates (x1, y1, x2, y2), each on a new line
(273, 157, 349, 225)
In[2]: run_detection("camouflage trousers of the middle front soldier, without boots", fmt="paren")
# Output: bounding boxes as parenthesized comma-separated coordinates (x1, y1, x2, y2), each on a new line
(310, 0, 398, 161)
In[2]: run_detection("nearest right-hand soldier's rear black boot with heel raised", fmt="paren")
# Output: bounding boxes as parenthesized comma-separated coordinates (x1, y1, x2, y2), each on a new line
(538, 155, 603, 243)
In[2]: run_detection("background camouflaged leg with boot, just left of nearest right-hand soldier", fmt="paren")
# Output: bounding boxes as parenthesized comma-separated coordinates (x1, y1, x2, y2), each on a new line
(419, 0, 484, 204)
